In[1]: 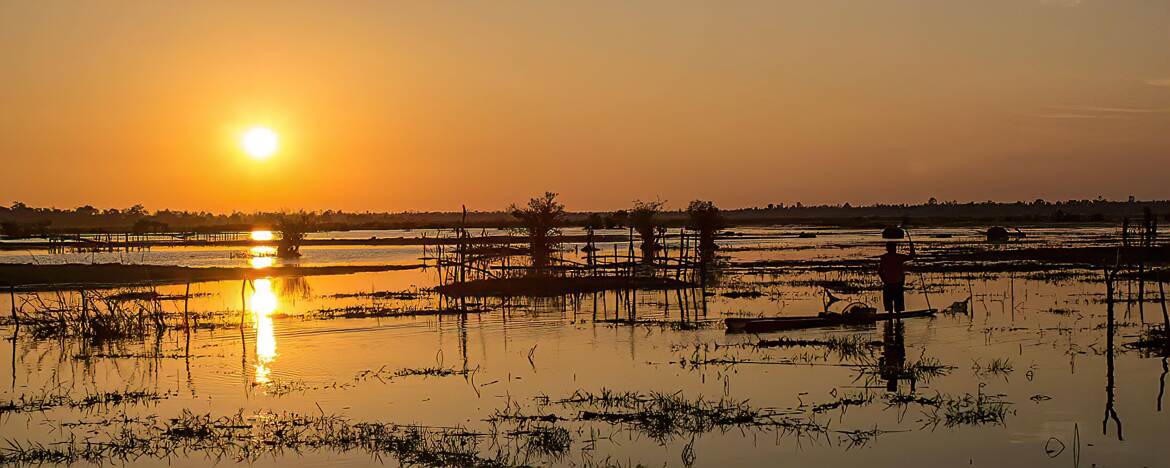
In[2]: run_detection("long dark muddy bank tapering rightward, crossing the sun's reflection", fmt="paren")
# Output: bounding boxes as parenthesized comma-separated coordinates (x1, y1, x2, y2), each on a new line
(0, 263, 420, 290)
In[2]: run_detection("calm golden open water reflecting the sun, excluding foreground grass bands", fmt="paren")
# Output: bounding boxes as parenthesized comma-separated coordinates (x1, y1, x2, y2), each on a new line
(0, 227, 1170, 467)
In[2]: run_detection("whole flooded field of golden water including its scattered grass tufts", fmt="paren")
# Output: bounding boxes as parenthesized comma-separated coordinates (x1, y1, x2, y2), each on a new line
(0, 226, 1170, 467)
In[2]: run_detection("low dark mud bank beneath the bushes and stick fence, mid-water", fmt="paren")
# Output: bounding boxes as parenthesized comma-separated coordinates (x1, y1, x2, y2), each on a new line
(435, 276, 694, 297)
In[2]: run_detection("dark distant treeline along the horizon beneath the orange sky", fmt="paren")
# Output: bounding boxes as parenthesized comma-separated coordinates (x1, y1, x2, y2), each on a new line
(0, 199, 1170, 238)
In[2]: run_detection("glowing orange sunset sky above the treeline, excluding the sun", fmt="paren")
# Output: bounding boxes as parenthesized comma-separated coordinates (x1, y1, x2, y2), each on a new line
(0, 0, 1170, 211)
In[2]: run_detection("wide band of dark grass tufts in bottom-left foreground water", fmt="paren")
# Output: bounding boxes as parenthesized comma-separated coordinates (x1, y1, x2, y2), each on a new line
(0, 410, 521, 467)
